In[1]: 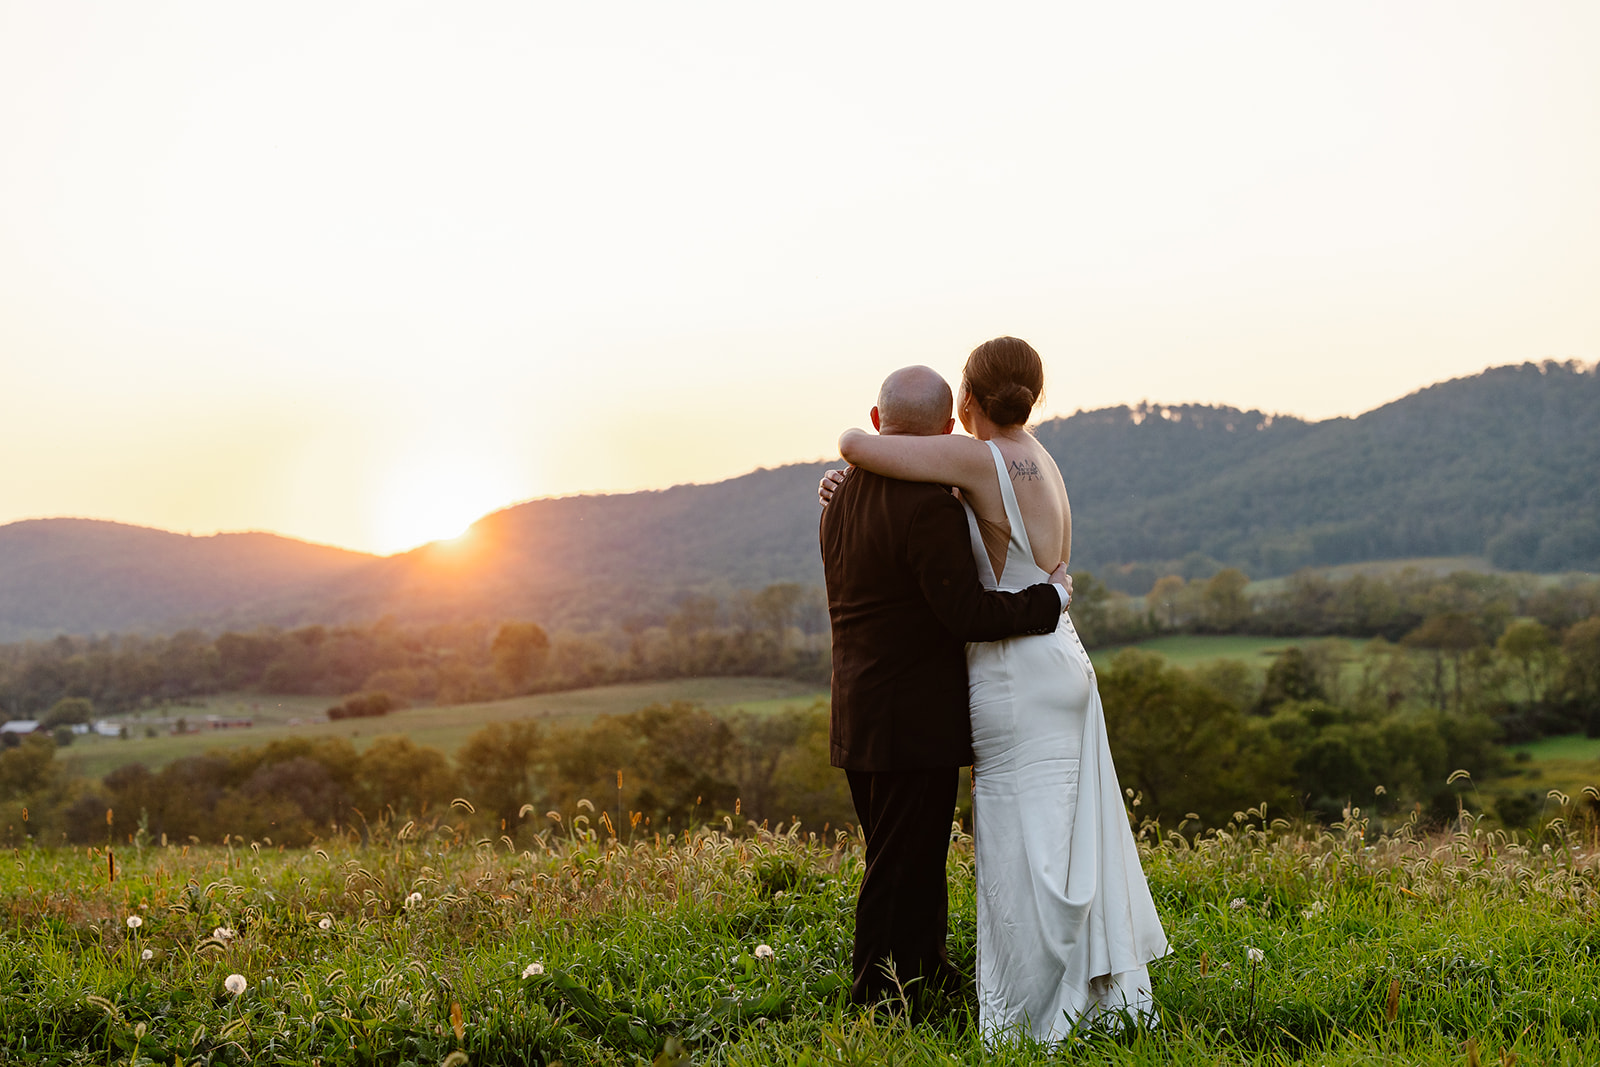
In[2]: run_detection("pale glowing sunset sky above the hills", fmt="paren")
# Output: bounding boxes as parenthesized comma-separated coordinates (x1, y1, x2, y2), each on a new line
(0, 0, 1600, 553)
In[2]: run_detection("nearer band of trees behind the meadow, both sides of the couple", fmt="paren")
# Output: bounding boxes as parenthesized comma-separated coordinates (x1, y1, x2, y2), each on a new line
(0, 601, 1600, 845)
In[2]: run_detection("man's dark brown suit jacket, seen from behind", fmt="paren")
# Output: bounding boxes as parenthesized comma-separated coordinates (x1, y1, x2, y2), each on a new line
(821, 467, 1061, 771)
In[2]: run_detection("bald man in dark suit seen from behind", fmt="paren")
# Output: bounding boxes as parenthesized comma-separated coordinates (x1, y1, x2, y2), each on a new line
(821, 366, 1070, 1003)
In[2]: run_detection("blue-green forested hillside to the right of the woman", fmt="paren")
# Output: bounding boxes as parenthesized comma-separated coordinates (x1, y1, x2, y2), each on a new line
(1038, 363, 1600, 592)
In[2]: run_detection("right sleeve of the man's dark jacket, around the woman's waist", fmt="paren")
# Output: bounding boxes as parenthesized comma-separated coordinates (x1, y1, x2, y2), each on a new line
(906, 494, 1061, 641)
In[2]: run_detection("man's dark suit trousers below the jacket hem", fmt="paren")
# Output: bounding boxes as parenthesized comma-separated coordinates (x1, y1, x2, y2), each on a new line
(845, 766, 960, 1003)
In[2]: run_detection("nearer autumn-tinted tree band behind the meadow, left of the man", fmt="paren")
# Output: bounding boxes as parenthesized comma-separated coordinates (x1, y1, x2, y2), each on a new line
(0, 702, 854, 846)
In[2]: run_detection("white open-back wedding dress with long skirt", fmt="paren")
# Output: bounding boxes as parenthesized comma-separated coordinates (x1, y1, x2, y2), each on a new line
(966, 442, 1168, 1041)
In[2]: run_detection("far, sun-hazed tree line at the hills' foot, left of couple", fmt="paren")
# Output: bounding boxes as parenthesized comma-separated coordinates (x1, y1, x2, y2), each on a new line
(0, 582, 827, 718)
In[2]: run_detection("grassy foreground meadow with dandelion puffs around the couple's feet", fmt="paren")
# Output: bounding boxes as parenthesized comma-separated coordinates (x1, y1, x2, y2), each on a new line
(0, 813, 1600, 1067)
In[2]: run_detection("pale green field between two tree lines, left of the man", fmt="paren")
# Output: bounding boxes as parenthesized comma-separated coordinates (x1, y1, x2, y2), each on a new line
(59, 678, 827, 777)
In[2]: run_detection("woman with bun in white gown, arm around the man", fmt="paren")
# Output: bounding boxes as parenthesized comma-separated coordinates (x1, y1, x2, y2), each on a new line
(822, 338, 1168, 1041)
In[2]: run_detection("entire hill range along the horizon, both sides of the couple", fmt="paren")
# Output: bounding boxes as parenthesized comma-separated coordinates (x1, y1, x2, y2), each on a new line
(0, 363, 1600, 640)
